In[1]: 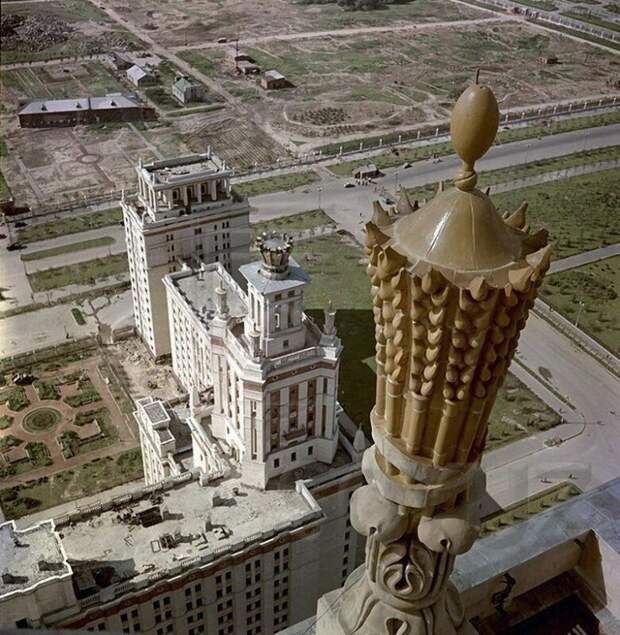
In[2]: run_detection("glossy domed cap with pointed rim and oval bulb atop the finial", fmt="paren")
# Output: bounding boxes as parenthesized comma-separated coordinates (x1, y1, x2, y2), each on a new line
(367, 84, 549, 286)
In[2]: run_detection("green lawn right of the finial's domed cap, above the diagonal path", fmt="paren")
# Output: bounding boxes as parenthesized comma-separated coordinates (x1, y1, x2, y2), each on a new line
(493, 170, 620, 259)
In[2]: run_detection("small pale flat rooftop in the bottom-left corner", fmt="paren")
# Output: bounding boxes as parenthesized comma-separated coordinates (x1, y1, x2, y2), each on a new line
(0, 521, 71, 597)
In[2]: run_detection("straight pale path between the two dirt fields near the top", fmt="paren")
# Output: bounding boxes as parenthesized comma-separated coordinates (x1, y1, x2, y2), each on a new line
(169, 15, 515, 52)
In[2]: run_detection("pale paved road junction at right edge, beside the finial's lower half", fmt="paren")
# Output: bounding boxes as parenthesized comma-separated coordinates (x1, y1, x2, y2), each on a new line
(487, 314, 620, 516)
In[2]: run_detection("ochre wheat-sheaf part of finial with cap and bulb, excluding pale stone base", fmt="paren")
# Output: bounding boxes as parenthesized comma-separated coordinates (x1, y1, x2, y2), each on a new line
(366, 78, 551, 469)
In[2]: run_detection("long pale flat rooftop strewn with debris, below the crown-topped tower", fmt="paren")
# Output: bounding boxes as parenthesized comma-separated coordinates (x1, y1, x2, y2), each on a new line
(59, 479, 315, 590)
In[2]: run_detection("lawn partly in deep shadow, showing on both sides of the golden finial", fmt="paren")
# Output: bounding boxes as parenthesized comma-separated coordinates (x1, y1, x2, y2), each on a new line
(300, 236, 560, 448)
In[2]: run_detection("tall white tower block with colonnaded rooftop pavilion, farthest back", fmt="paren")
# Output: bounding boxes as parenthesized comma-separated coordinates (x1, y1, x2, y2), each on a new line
(121, 150, 250, 357)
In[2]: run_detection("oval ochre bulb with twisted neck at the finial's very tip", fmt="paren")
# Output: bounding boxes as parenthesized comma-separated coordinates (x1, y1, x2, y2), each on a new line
(450, 78, 499, 192)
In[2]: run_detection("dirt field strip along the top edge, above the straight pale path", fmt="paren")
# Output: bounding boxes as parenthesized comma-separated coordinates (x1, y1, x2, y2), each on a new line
(110, 0, 488, 46)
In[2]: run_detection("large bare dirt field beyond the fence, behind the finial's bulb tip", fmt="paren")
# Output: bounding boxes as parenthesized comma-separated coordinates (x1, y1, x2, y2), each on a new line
(200, 21, 620, 143)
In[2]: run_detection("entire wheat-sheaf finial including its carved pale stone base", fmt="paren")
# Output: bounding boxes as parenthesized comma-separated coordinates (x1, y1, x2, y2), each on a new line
(317, 84, 551, 635)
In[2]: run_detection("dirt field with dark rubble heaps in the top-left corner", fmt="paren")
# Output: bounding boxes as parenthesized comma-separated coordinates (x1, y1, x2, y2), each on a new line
(1, 0, 144, 64)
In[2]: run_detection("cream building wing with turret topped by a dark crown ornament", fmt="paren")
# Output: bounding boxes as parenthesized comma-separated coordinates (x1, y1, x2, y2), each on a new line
(162, 236, 342, 488)
